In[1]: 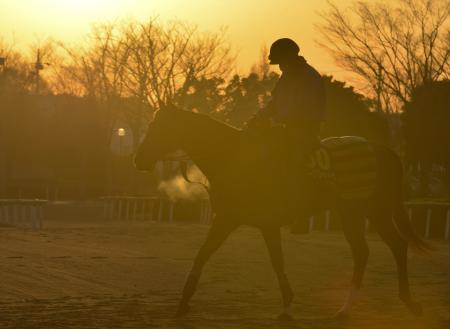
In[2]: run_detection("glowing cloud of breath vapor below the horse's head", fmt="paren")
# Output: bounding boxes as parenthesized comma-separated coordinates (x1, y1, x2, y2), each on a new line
(158, 166, 208, 202)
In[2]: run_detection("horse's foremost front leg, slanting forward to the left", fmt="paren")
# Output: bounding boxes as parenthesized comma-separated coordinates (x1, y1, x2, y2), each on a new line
(176, 218, 236, 317)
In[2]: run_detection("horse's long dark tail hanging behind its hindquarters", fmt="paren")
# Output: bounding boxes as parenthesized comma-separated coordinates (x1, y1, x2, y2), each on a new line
(386, 148, 432, 253)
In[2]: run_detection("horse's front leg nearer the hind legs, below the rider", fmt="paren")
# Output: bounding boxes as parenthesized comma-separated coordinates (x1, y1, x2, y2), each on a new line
(261, 227, 294, 319)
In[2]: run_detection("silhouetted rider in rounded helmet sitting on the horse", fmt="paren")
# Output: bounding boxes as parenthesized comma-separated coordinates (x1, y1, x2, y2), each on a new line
(248, 38, 325, 233)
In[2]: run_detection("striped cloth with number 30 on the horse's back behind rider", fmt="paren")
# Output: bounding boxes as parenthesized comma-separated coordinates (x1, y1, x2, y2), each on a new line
(307, 136, 377, 200)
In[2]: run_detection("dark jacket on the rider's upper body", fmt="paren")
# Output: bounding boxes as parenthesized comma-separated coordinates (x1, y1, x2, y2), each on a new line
(267, 56, 325, 127)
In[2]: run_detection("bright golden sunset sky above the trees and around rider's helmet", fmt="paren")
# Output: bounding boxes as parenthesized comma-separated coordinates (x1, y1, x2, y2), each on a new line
(0, 0, 351, 78)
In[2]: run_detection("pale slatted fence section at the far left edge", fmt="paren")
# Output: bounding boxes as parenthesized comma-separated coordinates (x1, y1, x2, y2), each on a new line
(0, 199, 47, 230)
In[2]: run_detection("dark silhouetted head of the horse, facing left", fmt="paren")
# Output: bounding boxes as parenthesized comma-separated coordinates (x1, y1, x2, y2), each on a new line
(134, 105, 182, 171)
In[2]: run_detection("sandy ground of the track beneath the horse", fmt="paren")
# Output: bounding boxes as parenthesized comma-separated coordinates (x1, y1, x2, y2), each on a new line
(0, 221, 450, 329)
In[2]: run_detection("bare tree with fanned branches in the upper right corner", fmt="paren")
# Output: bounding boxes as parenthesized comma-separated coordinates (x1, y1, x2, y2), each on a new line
(318, 0, 450, 111)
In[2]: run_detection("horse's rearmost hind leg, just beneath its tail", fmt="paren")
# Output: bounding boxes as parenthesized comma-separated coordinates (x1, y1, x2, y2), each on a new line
(371, 211, 422, 315)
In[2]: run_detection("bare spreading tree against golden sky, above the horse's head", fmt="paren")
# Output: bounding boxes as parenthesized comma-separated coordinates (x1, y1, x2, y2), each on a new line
(121, 18, 234, 108)
